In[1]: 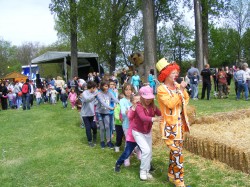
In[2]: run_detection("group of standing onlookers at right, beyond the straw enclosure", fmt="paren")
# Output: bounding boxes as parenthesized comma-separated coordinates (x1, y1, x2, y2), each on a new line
(185, 63, 250, 101)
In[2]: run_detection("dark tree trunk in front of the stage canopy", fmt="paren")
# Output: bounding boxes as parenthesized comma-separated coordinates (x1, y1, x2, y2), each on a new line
(70, 0, 78, 79)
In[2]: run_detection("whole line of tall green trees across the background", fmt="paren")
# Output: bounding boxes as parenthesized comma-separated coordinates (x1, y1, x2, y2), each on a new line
(0, 0, 250, 79)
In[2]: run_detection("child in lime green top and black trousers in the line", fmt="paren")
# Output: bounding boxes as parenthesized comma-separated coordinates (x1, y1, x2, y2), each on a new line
(114, 93, 124, 152)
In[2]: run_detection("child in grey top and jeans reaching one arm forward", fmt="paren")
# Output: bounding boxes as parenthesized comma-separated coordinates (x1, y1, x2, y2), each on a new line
(96, 81, 119, 149)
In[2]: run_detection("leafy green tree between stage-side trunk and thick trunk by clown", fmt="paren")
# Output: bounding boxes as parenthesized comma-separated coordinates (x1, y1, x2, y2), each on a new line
(79, 0, 138, 73)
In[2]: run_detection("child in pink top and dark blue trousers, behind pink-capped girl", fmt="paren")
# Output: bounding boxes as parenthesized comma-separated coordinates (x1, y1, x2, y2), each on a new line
(115, 95, 140, 172)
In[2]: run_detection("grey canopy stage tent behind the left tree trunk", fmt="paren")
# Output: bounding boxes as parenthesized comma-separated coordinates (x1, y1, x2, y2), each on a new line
(31, 51, 103, 80)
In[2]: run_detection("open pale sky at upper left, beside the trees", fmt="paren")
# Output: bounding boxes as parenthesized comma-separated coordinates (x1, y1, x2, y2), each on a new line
(0, 0, 57, 46)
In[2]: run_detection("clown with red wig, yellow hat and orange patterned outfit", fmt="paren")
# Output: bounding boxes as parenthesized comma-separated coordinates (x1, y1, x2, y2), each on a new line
(156, 58, 189, 187)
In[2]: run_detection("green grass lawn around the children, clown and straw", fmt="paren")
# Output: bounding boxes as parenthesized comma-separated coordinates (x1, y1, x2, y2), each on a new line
(0, 97, 250, 187)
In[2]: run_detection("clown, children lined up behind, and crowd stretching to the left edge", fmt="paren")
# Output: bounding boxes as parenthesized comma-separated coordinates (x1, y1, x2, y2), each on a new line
(0, 59, 193, 187)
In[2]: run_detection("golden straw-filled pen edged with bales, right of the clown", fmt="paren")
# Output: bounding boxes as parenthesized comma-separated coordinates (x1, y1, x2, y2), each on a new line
(184, 110, 250, 173)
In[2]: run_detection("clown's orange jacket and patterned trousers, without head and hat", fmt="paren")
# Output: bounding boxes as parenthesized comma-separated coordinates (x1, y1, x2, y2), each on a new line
(157, 58, 189, 187)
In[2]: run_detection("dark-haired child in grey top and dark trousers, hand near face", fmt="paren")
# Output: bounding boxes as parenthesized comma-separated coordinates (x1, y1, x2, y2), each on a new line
(81, 81, 99, 147)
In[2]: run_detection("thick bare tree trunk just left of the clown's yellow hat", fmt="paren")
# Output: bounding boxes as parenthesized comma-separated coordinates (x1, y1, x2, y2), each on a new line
(143, 0, 157, 82)
